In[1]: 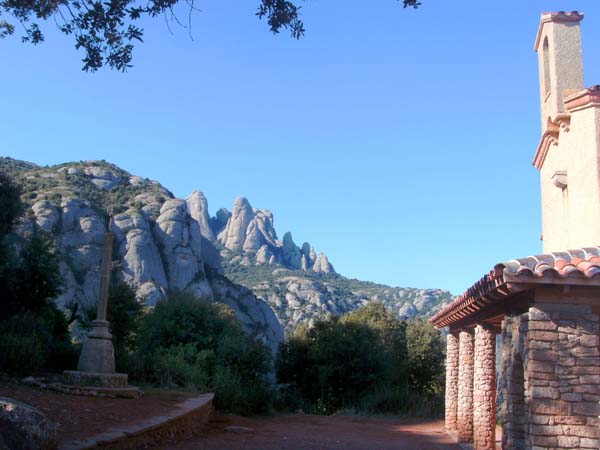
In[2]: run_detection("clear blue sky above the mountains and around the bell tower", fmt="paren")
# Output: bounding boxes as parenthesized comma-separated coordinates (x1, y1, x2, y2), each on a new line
(0, 0, 600, 294)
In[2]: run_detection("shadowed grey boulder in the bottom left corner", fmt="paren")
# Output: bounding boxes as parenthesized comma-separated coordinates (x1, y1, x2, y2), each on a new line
(0, 397, 58, 450)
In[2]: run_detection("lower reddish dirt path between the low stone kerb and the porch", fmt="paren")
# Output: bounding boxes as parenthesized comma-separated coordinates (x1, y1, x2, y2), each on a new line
(166, 415, 460, 450)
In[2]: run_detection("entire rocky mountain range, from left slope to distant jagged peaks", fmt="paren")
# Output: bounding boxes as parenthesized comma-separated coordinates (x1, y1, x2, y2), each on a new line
(0, 158, 452, 338)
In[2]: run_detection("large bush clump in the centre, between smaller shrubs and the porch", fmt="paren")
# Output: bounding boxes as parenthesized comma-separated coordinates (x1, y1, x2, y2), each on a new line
(277, 302, 444, 415)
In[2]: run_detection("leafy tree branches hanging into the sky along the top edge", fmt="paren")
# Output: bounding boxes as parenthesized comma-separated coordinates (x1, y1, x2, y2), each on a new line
(0, 0, 420, 72)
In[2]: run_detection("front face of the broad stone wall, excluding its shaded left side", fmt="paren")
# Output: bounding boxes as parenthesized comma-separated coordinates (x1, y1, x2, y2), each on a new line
(524, 302, 600, 450)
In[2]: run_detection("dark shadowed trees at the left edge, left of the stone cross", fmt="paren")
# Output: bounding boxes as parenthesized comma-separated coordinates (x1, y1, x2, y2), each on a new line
(0, 172, 76, 375)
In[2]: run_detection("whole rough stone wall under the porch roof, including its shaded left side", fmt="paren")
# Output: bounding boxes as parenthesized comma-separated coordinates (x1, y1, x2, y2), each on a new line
(501, 303, 600, 450)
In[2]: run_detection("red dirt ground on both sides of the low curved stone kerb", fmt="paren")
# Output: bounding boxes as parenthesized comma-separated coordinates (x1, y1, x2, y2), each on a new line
(0, 382, 478, 450)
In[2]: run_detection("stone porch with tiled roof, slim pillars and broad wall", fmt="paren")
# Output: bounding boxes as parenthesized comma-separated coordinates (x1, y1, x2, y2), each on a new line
(431, 247, 600, 450)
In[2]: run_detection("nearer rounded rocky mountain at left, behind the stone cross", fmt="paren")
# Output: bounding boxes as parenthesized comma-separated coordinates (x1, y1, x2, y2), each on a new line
(0, 158, 284, 350)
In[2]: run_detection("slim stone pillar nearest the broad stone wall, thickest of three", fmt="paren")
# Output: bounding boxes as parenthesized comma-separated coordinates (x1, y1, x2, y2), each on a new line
(473, 325, 496, 450)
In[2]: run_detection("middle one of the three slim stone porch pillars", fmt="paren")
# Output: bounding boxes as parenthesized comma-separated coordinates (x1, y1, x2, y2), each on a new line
(457, 331, 473, 442)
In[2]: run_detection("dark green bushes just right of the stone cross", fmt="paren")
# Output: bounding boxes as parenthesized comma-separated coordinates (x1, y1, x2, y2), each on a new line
(133, 292, 272, 414)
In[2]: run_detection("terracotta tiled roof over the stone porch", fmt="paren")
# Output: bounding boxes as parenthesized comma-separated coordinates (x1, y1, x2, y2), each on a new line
(430, 247, 600, 328)
